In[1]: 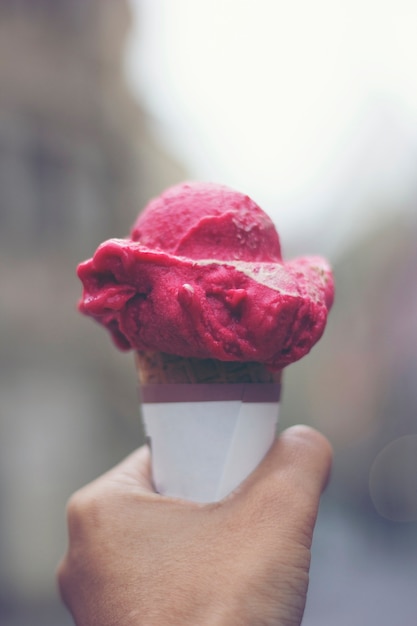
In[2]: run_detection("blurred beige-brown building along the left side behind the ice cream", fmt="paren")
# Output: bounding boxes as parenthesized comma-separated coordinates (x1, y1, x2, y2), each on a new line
(0, 0, 184, 625)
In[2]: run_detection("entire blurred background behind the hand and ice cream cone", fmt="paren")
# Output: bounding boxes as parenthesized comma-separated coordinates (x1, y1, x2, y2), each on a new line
(0, 0, 417, 626)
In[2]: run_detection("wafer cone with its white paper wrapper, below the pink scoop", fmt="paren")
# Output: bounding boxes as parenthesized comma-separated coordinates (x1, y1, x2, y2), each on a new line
(136, 351, 281, 502)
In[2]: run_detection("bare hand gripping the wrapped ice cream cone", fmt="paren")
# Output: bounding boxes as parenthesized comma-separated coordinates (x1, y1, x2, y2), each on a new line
(58, 426, 332, 626)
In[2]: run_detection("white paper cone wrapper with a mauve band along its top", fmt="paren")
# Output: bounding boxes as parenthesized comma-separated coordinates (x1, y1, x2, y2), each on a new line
(141, 384, 280, 502)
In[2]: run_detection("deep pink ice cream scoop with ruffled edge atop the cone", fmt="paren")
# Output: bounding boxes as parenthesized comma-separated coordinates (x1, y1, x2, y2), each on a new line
(78, 183, 334, 370)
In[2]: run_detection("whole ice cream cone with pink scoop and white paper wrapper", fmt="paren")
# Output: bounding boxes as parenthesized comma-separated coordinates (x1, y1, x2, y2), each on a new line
(77, 182, 334, 502)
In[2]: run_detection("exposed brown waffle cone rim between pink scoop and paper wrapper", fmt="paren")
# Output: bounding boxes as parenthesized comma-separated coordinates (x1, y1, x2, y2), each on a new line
(135, 351, 281, 385)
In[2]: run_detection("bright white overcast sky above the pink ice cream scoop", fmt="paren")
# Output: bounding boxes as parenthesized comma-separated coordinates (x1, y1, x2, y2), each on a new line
(127, 0, 417, 254)
